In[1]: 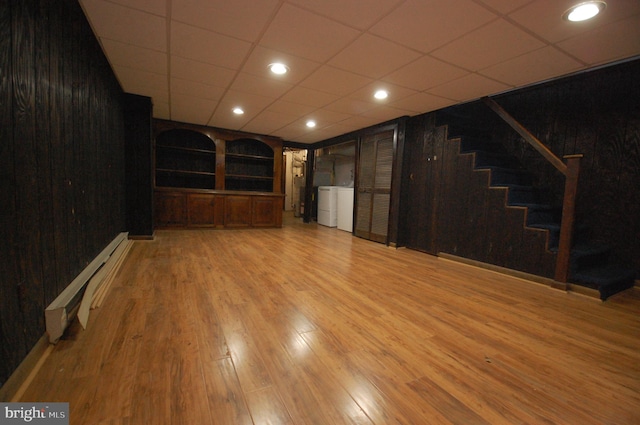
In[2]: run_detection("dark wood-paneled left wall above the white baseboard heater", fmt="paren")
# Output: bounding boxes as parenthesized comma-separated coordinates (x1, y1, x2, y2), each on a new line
(0, 0, 125, 385)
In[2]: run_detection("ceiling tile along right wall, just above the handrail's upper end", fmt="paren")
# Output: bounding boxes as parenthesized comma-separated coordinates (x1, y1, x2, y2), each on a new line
(480, 47, 582, 87)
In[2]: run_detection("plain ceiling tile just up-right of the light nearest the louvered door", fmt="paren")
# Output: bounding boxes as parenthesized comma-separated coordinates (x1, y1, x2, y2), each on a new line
(383, 56, 469, 91)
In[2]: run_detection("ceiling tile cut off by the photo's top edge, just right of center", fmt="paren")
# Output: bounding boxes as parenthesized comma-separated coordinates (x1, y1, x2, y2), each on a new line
(290, 0, 402, 30)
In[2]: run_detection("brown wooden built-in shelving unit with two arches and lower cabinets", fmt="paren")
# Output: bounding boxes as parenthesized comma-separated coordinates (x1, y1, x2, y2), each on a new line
(154, 120, 284, 228)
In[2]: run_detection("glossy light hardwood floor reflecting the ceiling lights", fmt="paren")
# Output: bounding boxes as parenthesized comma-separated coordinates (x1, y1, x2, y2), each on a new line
(22, 214, 640, 425)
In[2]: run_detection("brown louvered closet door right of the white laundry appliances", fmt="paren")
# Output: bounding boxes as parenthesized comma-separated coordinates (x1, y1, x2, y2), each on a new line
(355, 131, 393, 243)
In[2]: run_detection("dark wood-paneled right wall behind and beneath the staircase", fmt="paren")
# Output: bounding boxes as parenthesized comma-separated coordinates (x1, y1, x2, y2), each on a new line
(400, 60, 640, 276)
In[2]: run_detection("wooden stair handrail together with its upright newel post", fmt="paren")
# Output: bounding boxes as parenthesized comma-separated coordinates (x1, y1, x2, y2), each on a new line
(482, 97, 582, 289)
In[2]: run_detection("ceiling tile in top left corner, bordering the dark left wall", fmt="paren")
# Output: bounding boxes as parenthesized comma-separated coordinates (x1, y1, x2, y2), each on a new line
(83, 0, 167, 52)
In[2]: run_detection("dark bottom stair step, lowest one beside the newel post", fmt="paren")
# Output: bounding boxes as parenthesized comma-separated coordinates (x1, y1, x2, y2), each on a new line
(569, 264, 635, 301)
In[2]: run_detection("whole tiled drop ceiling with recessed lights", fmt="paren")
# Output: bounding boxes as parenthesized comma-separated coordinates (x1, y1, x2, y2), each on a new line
(80, 0, 640, 143)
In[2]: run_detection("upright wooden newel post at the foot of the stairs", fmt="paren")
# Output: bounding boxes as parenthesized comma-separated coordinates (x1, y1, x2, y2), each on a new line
(554, 155, 582, 287)
